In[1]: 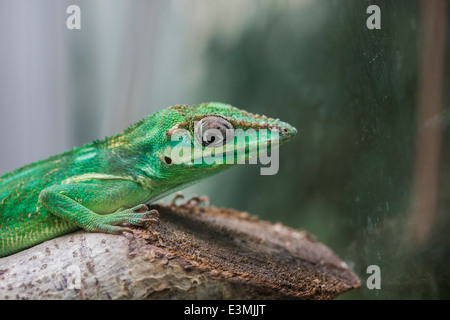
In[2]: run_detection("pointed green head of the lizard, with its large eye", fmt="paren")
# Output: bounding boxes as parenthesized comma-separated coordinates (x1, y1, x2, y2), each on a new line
(132, 102, 297, 194)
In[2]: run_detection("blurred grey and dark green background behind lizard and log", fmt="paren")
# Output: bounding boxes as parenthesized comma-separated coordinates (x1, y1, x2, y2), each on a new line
(0, 0, 450, 299)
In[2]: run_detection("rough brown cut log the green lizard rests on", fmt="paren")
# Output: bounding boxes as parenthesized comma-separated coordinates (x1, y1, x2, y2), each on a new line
(0, 205, 360, 299)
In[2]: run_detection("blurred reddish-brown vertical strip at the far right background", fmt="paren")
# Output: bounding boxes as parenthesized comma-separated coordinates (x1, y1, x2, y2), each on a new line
(406, 0, 447, 247)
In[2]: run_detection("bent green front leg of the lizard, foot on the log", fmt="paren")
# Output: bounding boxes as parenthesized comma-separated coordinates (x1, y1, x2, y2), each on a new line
(39, 180, 158, 233)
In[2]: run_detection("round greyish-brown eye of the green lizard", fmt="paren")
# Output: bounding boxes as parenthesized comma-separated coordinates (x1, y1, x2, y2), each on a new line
(194, 116, 234, 148)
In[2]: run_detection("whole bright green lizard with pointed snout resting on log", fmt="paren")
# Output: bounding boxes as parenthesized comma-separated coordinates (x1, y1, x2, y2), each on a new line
(0, 103, 296, 257)
